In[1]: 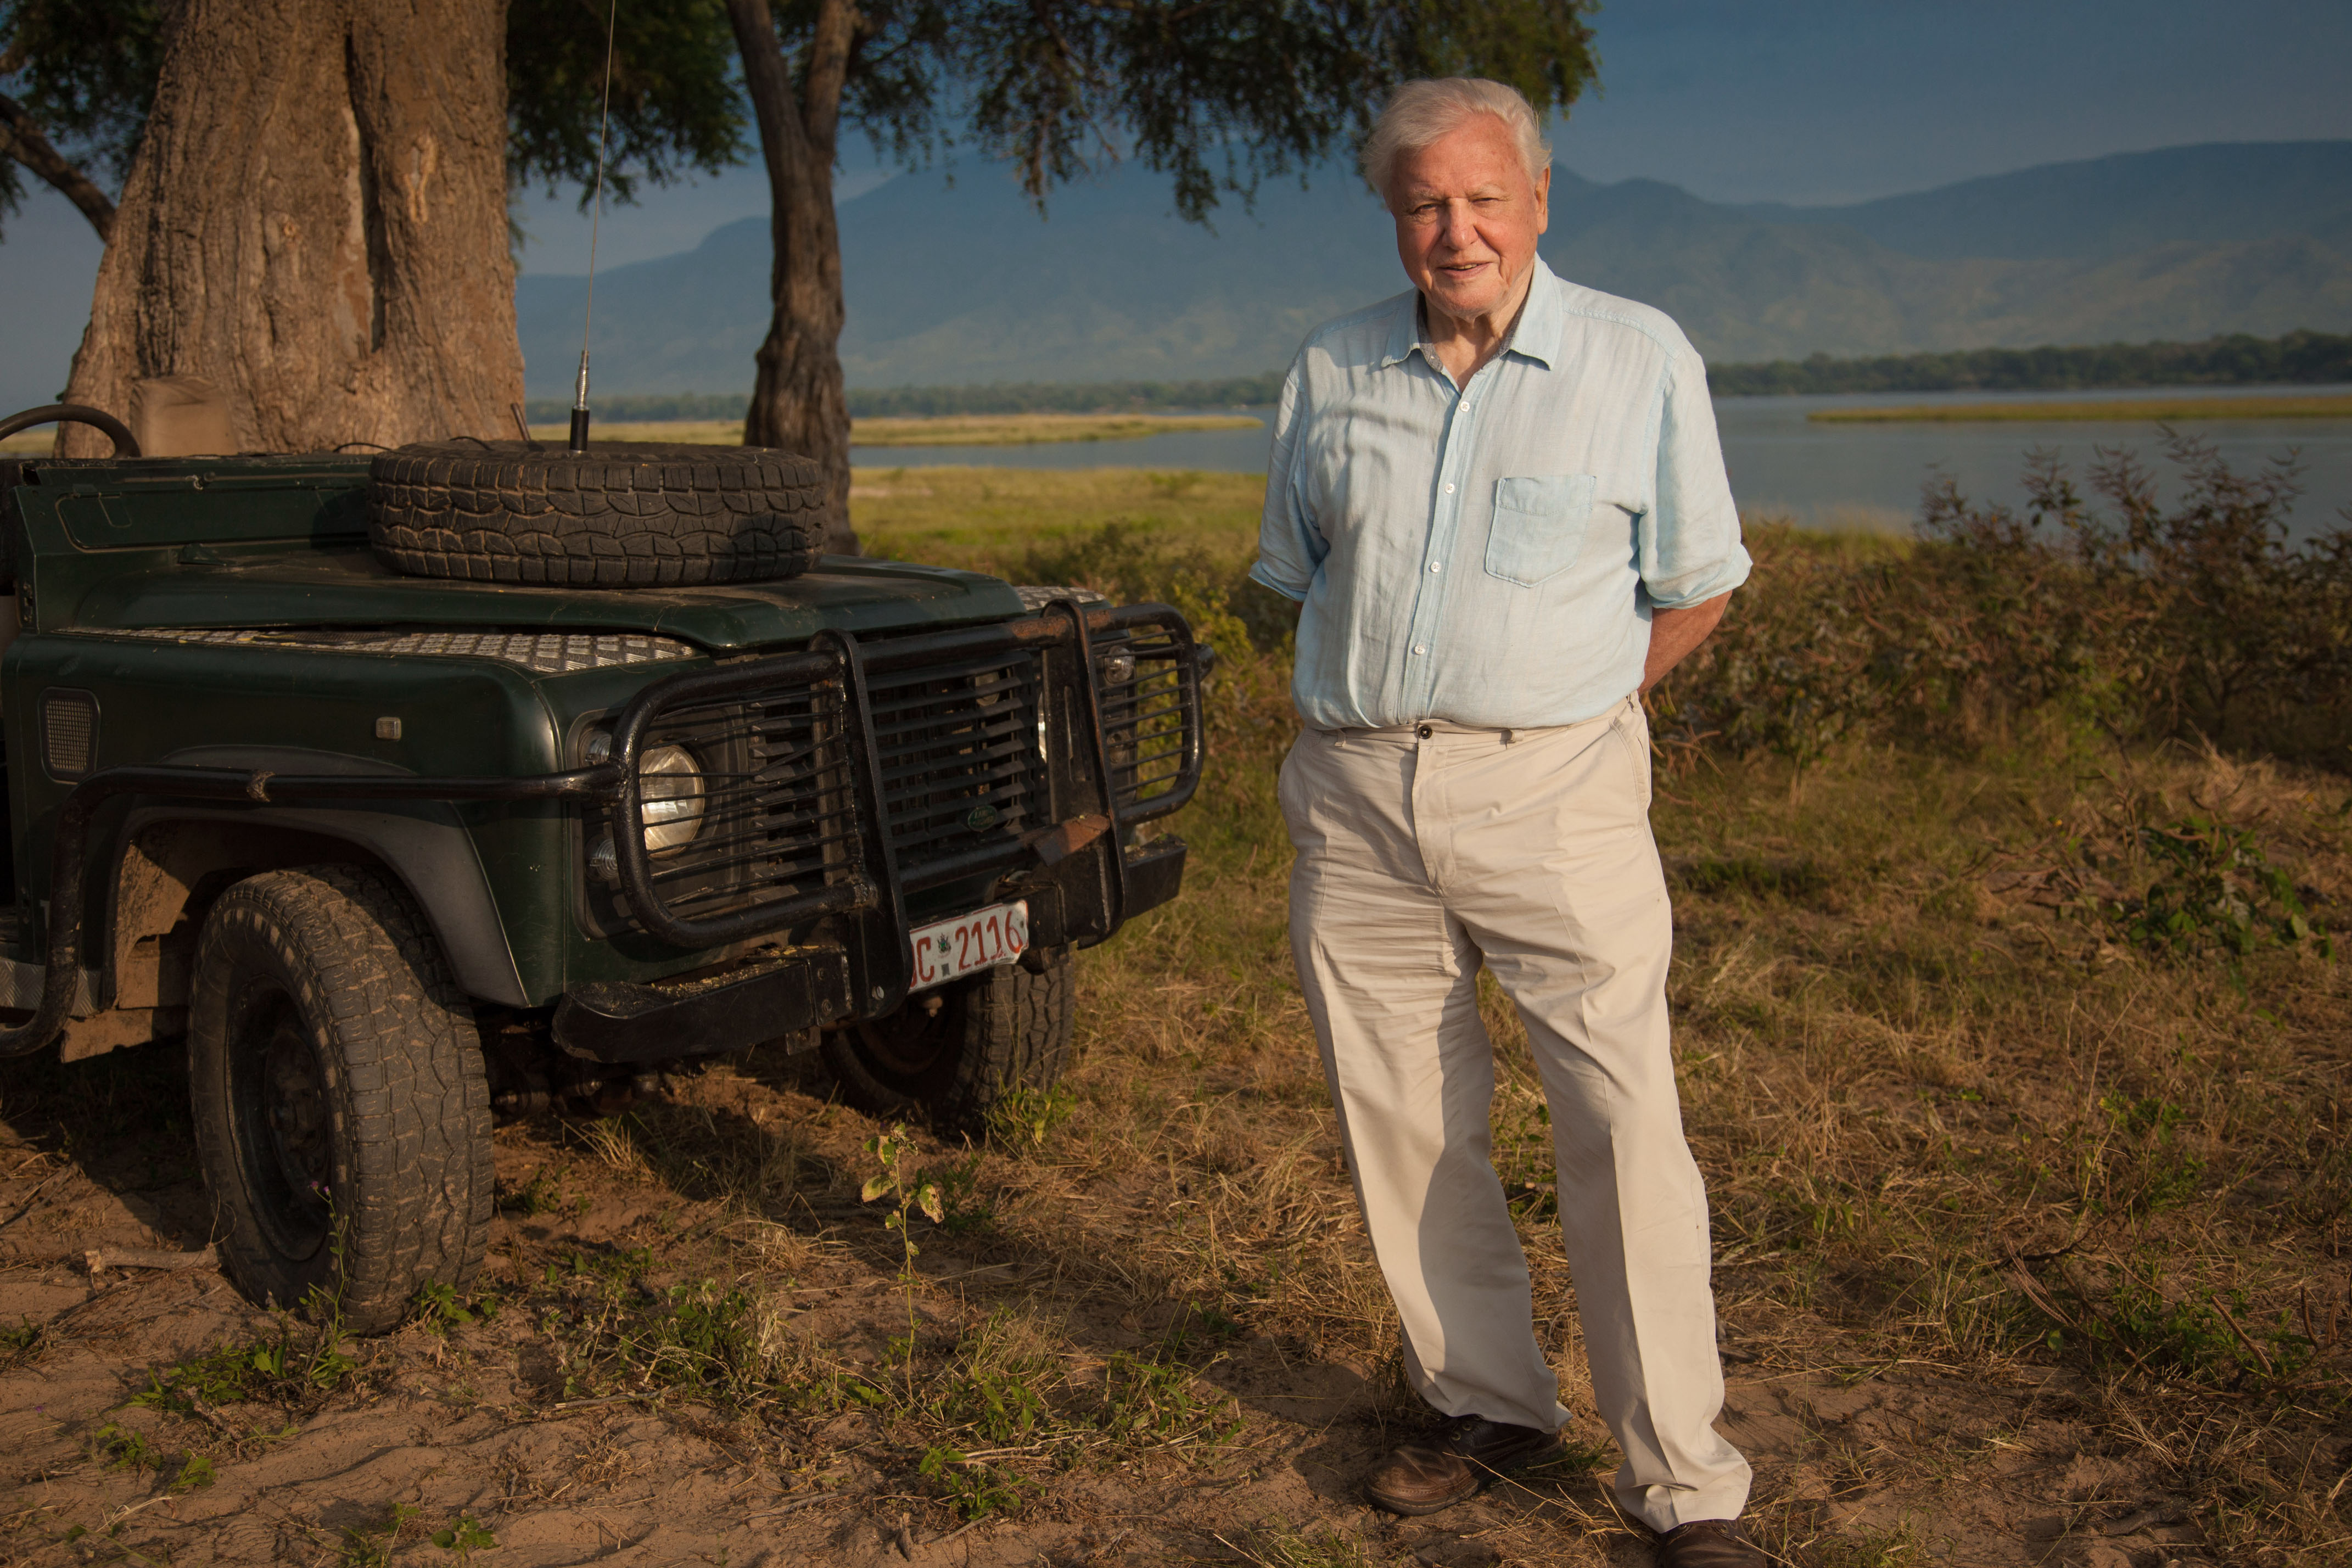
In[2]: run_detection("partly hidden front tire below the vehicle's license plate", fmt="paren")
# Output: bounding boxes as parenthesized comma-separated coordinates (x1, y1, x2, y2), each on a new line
(823, 948, 1077, 1133)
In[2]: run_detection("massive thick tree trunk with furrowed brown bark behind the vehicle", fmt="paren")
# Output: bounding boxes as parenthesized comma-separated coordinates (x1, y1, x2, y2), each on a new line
(59, 0, 522, 456)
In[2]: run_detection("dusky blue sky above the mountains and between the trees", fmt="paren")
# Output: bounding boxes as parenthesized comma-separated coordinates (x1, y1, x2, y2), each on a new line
(0, 0, 2352, 407)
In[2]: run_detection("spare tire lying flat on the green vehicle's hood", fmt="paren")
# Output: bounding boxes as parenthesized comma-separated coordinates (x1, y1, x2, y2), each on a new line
(367, 440, 826, 587)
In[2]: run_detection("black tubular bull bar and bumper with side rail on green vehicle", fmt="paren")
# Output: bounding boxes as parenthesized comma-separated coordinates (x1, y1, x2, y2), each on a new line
(0, 600, 1209, 1062)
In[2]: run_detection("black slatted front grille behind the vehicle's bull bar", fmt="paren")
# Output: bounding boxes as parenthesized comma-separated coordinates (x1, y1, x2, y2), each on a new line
(607, 607, 1202, 945)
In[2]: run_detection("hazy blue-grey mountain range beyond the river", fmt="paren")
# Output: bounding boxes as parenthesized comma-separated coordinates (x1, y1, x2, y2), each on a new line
(515, 141, 2352, 395)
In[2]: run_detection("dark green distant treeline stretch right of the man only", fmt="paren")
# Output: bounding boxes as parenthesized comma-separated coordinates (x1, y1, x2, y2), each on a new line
(1707, 332, 2352, 397)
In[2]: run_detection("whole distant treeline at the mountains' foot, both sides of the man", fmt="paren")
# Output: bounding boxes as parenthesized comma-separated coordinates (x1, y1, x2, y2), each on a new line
(539, 332, 2352, 423)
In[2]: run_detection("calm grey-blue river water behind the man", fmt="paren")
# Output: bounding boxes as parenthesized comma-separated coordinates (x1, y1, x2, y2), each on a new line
(852, 385, 2352, 534)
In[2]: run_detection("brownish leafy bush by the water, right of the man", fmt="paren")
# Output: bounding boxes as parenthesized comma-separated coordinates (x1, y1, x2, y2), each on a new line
(1654, 435, 2352, 769)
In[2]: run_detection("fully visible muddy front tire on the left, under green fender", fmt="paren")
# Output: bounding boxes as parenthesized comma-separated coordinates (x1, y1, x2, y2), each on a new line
(188, 865, 494, 1333)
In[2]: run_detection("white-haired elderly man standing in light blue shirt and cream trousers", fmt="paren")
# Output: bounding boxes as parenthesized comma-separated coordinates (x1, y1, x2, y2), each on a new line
(1251, 80, 1766, 1568)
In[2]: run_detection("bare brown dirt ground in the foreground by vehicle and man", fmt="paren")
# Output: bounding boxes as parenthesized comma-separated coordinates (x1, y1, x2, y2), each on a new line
(0, 1029, 2239, 1568)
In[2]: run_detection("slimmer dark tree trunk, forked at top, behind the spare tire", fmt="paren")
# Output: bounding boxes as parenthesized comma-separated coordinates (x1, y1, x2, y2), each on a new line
(727, 0, 859, 555)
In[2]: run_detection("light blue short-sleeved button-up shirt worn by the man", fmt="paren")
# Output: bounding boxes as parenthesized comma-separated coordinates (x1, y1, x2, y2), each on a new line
(1249, 259, 1748, 729)
